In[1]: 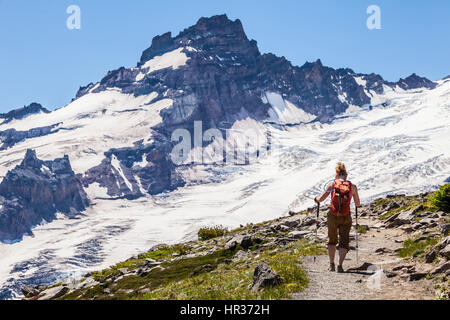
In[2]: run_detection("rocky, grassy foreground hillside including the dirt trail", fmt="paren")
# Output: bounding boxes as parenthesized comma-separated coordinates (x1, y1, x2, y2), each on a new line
(22, 194, 450, 300)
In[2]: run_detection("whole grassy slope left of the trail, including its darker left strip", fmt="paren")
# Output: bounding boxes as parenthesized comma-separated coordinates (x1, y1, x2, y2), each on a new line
(63, 239, 326, 300)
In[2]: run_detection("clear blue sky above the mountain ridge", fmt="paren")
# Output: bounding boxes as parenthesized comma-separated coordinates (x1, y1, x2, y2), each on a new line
(0, 0, 450, 112)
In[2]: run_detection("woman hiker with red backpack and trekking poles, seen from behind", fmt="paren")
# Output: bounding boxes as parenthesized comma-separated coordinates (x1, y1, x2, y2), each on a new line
(314, 162, 360, 272)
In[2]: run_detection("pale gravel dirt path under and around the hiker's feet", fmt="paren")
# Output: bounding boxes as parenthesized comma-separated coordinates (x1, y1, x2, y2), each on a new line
(292, 214, 436, 300)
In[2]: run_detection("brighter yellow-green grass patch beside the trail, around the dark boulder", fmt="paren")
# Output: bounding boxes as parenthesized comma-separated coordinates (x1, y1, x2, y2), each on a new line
(142, 240, 325, 300)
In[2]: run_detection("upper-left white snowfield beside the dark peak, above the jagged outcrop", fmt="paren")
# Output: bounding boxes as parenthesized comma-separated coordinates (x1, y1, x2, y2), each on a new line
(0, 89, 172, 177)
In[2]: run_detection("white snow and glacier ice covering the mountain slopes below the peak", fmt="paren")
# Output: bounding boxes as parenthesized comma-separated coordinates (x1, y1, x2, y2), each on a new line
(0, 80, 450, 298)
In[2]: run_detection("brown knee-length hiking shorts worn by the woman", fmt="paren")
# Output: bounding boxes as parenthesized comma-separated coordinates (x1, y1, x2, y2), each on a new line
(327, 212, 352, 250)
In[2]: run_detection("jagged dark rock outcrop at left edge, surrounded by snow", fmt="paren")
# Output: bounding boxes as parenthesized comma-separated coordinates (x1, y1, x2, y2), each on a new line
(0, 150, 88, 241)
